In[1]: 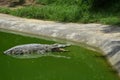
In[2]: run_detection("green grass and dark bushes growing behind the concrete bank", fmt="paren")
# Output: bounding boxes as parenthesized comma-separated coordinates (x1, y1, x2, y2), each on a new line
(0, 0, 120, 25)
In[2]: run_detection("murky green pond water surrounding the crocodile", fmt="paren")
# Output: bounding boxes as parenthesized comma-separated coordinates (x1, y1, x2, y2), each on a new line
(0, 32, 120, 80)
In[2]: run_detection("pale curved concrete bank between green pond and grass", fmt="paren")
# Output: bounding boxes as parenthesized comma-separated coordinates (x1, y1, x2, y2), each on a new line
(0, 14, 120, 75)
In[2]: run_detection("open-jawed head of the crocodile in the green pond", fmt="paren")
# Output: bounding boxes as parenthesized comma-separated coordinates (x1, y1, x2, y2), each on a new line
(52, 43, 70, 52)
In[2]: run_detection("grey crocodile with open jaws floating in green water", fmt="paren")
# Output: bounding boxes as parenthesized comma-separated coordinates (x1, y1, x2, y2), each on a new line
(4, 43, 70, 55)
